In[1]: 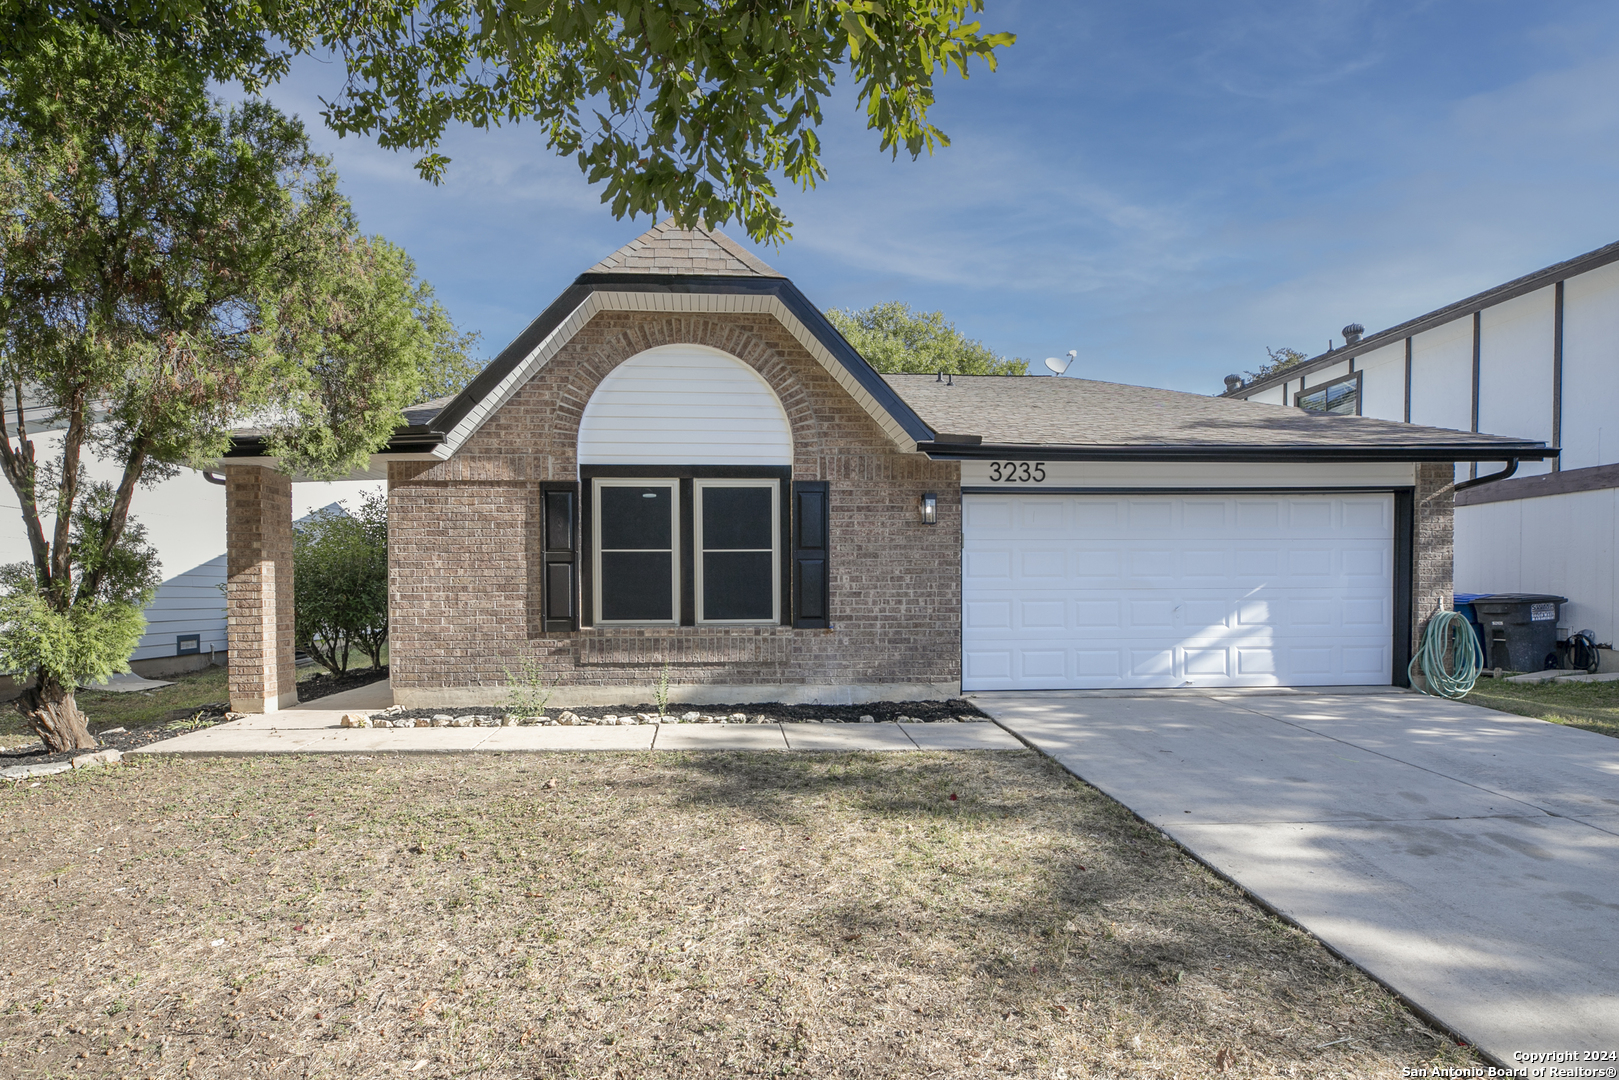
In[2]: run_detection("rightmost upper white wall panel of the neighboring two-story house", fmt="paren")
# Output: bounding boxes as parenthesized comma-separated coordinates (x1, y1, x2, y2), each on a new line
(1562, 262, 1619, 469)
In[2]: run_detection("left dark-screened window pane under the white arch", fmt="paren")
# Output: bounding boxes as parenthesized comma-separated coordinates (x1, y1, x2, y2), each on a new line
(597, 486, 675, 622)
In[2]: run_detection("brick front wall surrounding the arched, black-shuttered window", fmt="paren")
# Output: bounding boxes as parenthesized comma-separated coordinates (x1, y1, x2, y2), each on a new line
(389, 313, 962, 703)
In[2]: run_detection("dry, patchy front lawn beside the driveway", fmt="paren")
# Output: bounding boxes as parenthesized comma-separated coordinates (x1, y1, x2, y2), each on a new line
(0, 751, 1478, 1080)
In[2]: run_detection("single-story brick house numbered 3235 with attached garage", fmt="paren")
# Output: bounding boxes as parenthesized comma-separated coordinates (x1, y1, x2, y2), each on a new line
(223, 223, 1549, 711)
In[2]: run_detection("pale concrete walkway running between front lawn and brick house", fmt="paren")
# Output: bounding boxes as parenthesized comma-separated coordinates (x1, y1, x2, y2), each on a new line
(131, 709, 1023, 756)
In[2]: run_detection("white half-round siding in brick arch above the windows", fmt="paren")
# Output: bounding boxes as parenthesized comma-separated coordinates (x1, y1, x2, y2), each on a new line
(580, 345, 793, 465)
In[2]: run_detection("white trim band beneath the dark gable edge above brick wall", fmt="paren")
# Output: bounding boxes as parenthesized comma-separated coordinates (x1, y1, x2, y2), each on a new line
(430, 291, 916, 461)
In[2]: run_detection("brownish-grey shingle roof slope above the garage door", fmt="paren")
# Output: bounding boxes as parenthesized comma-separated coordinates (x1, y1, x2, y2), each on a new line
(884, 374, 1554, 450)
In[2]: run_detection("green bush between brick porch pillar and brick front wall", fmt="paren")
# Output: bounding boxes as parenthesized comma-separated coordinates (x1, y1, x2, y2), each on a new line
(293, 492, 389, 675)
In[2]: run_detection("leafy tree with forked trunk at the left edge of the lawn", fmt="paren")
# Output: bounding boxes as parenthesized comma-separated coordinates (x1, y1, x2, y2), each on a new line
(0, 28, 469, 750)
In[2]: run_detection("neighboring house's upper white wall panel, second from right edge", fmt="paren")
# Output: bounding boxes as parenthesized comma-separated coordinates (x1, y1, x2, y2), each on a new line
(1465, 288, 1556, 476)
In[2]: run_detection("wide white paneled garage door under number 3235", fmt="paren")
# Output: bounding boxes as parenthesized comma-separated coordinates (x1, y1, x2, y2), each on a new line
(962, 492, 1394, 690)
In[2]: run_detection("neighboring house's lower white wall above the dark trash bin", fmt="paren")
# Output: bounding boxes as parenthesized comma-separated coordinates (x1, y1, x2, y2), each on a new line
(1455, 489, 1619, 641)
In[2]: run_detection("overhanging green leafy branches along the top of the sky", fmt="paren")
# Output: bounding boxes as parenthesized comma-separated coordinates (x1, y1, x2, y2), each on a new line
(0, 0, 1015, 243)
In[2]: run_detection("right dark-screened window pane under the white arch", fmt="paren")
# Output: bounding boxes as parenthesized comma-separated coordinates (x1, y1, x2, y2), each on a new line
(701, 486, 776, 620)
